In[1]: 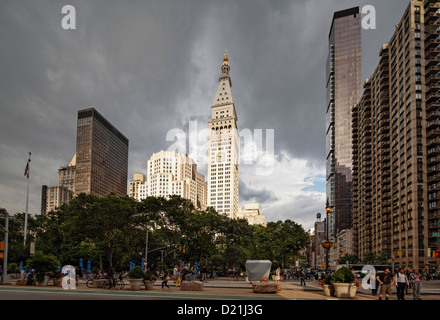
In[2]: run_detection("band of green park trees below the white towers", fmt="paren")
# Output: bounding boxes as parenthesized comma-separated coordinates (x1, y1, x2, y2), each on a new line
(0, 193, 309, 274)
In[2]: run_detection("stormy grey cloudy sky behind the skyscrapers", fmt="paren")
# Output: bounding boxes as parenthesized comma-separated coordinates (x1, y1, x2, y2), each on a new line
(0, 0, 409, 230)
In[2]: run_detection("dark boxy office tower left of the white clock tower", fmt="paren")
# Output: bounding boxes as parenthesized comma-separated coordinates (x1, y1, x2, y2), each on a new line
(75, 108, 128, 196)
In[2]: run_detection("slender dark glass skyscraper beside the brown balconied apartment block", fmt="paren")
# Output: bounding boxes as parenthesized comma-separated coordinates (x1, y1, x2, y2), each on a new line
(326, 7, 362, 237)
